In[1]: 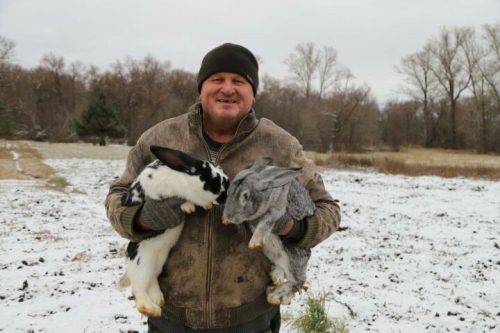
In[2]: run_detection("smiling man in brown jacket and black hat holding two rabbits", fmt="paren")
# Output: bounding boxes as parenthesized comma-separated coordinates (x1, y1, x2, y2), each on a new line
(106, 43, 340, 333)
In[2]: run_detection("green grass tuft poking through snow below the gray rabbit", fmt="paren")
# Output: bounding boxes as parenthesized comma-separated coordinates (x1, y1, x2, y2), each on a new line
(292, 293, 349, 333)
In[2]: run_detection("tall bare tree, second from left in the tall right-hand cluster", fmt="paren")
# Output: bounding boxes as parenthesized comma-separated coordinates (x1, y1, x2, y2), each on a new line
(427, 28, 470, 149)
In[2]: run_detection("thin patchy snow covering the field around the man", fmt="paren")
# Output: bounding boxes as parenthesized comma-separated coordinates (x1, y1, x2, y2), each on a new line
(0, 159, 500, 333)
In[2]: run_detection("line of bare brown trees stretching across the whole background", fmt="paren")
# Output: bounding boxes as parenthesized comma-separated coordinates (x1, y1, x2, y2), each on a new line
(0, 24, 500, 153)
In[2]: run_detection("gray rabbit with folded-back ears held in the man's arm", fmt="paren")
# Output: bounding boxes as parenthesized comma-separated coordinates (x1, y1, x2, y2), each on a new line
(222, 157, 315, 305)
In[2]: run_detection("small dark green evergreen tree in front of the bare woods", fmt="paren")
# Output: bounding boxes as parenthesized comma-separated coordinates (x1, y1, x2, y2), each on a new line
(76, 93, 125, 146)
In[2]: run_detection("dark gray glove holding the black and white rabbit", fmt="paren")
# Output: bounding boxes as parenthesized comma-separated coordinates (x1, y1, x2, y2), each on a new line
(141, 197, 186, 231)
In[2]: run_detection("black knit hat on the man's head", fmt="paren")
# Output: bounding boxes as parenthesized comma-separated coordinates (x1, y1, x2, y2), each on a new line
(198, 43, 259, 96)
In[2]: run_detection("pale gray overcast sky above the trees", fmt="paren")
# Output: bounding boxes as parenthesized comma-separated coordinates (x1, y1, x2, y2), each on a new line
(0, 0, 500, 102)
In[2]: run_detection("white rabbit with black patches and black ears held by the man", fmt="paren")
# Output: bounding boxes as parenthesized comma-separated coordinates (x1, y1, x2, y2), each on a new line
(119, 146, 229, 317)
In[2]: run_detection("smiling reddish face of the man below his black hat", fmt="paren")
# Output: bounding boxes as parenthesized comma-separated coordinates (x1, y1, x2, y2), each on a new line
(200, 72, 255, 126)
